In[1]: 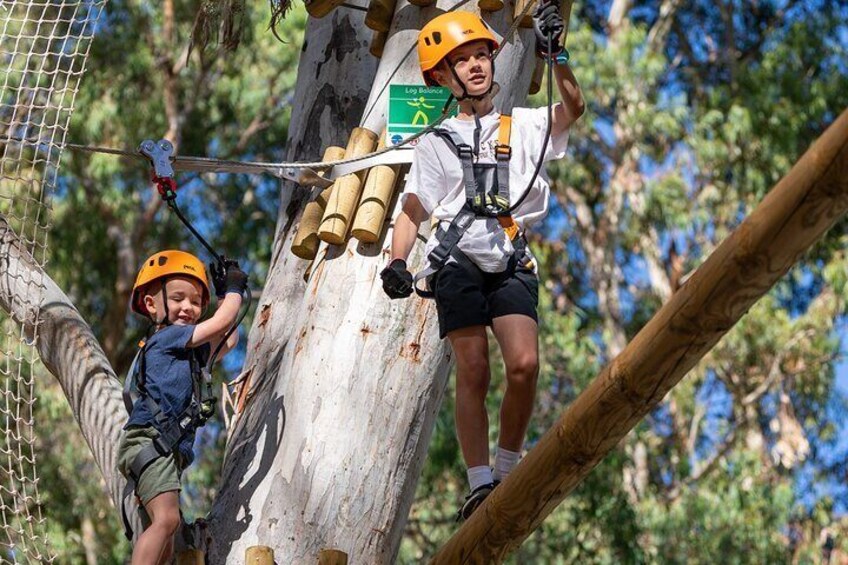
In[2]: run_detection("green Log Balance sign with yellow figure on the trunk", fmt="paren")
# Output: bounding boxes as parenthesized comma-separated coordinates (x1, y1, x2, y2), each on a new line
(386, 84, 456, 146)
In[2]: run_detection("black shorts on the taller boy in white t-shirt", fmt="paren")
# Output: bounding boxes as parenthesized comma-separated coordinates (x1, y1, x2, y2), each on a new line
(431, 254, 539, 338)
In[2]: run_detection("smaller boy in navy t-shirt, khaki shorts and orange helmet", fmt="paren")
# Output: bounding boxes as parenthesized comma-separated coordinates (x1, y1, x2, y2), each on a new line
(118, 251, 247, 565)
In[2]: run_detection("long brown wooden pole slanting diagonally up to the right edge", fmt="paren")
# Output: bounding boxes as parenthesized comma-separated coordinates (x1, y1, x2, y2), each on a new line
(433, 110, 848, 564)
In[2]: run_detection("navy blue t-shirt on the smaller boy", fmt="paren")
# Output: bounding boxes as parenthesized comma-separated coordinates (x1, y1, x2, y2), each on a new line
(124, 325, 211, 465)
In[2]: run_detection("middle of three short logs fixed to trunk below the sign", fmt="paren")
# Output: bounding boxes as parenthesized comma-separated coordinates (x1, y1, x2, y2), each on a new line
(318, 127, 377, 245)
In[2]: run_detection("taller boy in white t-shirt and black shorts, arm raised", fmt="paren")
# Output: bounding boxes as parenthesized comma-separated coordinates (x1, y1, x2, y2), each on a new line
(381, 6, 583, 519)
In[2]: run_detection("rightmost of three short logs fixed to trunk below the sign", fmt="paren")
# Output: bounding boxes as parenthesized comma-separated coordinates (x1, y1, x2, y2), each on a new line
(350, 130, 400, 243)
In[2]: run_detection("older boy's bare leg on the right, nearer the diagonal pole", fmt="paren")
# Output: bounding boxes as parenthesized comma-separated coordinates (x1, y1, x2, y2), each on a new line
(492, 314, 539, 452)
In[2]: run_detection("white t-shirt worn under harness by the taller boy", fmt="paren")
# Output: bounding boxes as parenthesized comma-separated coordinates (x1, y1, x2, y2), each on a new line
(401, 106, 568, 273)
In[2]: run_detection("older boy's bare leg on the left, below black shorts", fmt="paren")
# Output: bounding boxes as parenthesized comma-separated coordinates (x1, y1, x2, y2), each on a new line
(447, 326, 489, 468)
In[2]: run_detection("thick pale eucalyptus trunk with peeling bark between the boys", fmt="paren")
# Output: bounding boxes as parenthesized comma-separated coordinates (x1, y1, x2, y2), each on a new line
(205, 1, 532, 563)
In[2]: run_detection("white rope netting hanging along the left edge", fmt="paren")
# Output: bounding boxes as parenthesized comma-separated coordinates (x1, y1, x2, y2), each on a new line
(0, 0, 107, 563)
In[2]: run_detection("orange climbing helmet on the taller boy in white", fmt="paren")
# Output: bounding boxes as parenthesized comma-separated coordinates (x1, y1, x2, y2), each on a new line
(418, 11, 499, 86)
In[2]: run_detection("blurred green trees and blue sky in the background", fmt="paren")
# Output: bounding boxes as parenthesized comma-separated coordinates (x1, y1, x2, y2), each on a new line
(11, 0, 848, 563)
